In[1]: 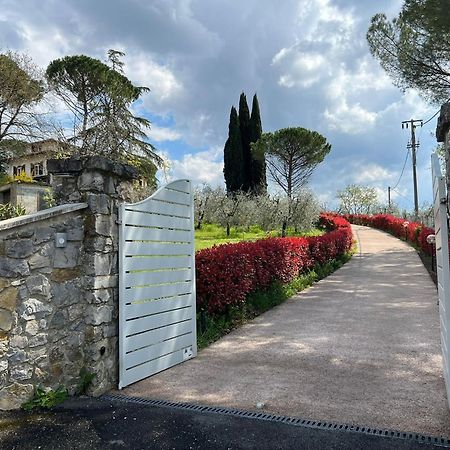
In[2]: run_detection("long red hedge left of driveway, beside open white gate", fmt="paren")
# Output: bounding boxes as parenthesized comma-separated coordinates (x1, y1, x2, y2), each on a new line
(195, 214, 352, 314)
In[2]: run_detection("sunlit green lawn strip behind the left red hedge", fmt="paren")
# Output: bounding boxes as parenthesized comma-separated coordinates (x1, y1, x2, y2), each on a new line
(195, 224, 323, 250)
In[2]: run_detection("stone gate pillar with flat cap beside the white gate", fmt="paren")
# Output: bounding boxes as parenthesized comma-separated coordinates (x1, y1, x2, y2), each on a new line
(47, 156, 137, 395)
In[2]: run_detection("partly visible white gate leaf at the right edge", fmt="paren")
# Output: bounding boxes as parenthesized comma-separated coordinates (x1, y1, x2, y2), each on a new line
(431, 154, 450, 406)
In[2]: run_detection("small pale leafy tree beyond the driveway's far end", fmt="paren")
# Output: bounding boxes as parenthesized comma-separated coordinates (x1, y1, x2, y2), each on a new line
(337, 184, 379, 214)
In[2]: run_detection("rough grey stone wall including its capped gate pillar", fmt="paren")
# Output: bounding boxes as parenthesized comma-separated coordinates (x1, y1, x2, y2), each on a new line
(0, 157, 136, 409)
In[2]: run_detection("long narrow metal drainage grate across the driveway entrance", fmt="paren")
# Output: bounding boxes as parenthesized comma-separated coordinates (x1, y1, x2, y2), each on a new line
(100, 394, 450, 448)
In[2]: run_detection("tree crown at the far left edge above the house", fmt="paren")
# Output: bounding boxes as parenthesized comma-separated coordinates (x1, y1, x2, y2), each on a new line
(0, 51, 45, 145)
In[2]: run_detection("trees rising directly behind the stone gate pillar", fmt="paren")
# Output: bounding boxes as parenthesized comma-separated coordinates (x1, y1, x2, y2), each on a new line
(46, 50, 162, 183)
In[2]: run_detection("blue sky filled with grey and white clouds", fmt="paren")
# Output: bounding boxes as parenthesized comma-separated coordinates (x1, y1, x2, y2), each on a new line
(0, 0, 437, 209)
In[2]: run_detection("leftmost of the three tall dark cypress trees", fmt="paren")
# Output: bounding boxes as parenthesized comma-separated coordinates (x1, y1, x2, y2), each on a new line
(223, 106, 244, 194)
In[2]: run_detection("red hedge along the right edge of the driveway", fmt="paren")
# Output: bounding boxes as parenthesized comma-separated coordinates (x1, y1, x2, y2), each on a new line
(344, 214, 434, 256)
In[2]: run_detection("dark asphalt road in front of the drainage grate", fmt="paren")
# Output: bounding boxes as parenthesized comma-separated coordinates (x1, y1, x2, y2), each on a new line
(0, 398, 448, 450)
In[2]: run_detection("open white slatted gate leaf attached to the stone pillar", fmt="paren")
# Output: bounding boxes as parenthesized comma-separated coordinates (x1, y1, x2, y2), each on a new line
(119, 180, 197, 389)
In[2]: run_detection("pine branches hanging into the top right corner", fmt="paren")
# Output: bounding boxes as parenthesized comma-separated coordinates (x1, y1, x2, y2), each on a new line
(367, 0, 450, 103)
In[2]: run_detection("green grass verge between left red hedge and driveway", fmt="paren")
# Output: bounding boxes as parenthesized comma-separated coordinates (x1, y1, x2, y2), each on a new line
(197, 247, 356, 350)
